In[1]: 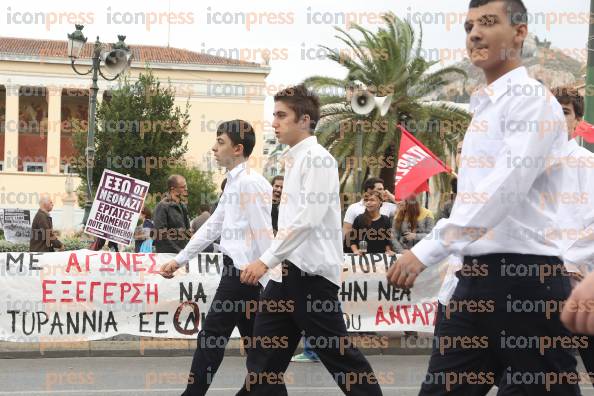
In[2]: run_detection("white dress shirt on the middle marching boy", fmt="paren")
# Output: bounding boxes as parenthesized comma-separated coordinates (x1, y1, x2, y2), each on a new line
(260, 136, 344, 286)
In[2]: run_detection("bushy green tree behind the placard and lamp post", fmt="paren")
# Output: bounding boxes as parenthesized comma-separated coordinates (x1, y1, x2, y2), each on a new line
(73, 69, 214, 217)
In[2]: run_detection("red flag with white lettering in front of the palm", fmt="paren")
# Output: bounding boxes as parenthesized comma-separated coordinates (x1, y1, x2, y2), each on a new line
(394, 126, 450, 200)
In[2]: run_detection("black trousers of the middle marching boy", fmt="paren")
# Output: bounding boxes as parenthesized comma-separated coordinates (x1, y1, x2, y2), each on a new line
(237, 261, 382, 396)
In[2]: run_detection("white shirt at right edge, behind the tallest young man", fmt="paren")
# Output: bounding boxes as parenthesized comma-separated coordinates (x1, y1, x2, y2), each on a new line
(551, 139, 594, 271)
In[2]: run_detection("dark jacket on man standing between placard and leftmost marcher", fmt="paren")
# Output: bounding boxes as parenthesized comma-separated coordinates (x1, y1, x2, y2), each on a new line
(153, 196, 192, 253)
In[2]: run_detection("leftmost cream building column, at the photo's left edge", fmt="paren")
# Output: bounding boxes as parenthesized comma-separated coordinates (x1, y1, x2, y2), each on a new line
(4, 85, 19, 172)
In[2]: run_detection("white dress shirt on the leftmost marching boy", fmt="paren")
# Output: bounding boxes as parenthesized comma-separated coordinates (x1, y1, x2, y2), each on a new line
(175, 162, 273, 285)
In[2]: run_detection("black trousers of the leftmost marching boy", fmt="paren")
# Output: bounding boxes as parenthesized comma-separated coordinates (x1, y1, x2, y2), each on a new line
(183, 256, 260, 396)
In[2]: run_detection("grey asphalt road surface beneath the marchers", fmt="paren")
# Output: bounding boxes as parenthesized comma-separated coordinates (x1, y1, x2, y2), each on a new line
(0, 355, 594, 396)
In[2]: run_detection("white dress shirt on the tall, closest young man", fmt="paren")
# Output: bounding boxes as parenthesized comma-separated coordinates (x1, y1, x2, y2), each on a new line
(411, 67, 568, 266)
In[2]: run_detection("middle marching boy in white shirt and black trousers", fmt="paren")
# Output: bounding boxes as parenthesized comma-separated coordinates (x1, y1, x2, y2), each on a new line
(237, 85, 382, 396)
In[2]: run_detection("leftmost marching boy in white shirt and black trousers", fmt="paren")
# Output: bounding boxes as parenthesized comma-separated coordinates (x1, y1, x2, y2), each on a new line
(161, 120, 280, 396)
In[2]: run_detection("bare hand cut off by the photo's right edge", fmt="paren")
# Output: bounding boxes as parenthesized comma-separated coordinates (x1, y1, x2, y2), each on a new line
(561, 273, 594, 335)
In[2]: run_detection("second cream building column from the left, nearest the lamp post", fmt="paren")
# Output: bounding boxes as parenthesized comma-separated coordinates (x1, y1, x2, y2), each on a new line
(46, 87, 62, 174)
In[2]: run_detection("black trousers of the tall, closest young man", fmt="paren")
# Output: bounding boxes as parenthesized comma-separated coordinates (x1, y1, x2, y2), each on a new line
(419, 254, 580, 396)
